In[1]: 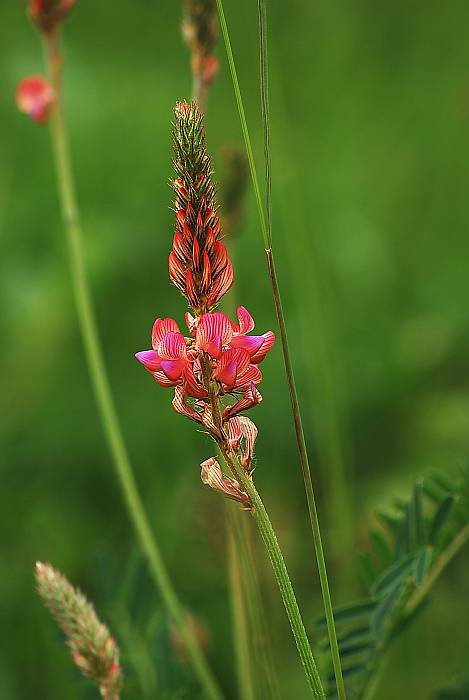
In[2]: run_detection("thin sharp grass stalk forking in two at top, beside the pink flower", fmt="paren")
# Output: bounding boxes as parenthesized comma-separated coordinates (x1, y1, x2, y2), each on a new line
(217, 0, 346, 700)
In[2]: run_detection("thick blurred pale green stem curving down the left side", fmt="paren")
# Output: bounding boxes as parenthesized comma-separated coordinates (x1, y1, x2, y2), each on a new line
(45, 34, 222, 700)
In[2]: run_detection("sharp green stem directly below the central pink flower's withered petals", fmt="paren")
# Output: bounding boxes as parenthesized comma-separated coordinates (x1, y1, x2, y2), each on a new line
(220, 444, 325, 700)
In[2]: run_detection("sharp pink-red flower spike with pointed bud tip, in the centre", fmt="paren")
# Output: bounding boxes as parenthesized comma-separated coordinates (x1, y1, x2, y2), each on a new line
(136, 102, 275, 506)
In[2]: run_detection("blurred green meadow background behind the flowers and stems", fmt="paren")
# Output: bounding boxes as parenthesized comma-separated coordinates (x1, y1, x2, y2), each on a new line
(0, 0, 469, 700)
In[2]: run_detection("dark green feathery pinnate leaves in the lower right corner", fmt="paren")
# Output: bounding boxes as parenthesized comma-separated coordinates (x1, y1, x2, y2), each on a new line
(317, 469, 469, 700)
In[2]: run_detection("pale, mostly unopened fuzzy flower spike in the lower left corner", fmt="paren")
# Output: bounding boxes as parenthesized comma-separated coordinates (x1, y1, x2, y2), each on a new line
(36, 562, 122, 700)
